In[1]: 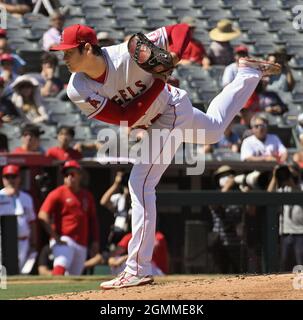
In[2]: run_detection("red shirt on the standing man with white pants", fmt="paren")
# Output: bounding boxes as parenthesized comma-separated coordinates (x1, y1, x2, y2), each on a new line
(40, 185, 99, 246)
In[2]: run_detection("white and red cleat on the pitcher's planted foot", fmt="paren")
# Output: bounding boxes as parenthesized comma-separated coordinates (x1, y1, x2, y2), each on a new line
(100, 271, 154, 290)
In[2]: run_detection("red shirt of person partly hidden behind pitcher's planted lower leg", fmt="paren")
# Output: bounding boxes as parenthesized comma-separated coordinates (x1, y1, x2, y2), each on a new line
(118, 231, 168, 274)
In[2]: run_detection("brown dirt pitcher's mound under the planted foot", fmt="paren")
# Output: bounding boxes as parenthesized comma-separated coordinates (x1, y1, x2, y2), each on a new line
(25, 274, 303, 300)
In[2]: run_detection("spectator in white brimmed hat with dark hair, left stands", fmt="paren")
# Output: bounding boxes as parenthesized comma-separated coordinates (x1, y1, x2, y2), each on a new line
(11, 75, 49, 123)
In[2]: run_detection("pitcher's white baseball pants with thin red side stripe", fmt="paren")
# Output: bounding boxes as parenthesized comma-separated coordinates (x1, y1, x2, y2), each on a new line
(125, 68, 262, 276)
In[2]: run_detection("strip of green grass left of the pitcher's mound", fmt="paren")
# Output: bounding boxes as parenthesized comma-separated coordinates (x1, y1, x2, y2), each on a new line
(0, 276, 110, 300)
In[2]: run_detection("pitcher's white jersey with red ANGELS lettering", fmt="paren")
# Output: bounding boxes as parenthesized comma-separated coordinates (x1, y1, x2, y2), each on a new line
(67, 27, 186, 127)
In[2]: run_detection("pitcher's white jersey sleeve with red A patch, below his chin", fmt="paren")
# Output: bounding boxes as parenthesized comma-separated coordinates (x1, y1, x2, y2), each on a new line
(67, 74, 108, 119)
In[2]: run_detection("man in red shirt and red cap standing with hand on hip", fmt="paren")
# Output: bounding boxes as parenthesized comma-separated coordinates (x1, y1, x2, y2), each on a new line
(39, 160, 99, 275)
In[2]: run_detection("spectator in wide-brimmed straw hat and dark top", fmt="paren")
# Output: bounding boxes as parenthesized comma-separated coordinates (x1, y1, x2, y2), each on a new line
(207, 19, 241, 66)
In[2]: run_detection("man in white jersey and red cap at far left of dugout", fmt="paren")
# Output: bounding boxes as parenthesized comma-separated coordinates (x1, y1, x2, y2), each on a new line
(0, 164, 36, 273)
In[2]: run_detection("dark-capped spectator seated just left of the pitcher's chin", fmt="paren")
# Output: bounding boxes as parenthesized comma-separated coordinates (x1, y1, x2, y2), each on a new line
(30, 52, 63, 97)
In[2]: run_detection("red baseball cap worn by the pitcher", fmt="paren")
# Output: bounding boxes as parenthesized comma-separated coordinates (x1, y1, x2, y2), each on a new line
(50, 24, 98, 51)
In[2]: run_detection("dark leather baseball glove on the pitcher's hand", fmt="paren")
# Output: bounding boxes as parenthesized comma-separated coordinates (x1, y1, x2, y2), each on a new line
(127, 32, 175, 78)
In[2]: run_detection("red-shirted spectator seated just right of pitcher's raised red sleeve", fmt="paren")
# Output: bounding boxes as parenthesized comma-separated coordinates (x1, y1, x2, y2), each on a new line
(179, 16, 206, 65)
